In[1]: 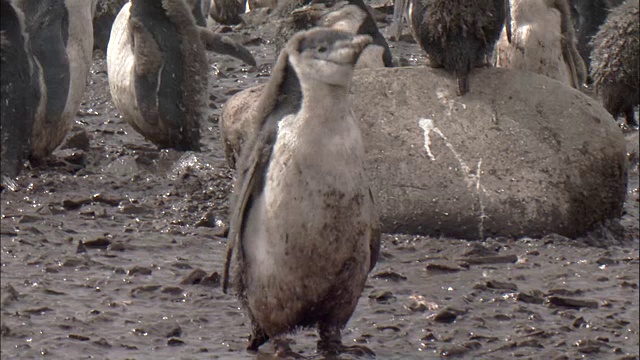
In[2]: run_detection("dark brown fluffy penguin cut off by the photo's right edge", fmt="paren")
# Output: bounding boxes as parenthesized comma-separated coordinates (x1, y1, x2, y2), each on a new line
(590, 0, 640, 127)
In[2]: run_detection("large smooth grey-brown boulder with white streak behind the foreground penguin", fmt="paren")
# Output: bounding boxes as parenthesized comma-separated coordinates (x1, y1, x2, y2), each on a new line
(351, 67, 627, 239)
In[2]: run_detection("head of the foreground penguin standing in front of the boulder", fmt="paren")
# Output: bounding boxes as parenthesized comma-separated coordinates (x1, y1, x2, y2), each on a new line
(287, 28, 372, 86)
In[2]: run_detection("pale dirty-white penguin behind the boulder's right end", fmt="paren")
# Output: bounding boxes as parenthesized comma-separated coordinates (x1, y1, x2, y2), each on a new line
(496, 0, 587, 89)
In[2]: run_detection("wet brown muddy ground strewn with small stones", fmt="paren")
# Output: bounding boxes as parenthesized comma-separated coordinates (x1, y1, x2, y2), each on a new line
(0, 5, 640, 359)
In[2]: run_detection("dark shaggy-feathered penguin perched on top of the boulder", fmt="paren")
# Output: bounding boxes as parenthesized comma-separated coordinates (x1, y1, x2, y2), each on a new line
(396, 0, 509, 95)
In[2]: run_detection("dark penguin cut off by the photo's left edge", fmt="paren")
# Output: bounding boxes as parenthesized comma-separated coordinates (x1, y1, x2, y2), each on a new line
(0, 0, 46, 177)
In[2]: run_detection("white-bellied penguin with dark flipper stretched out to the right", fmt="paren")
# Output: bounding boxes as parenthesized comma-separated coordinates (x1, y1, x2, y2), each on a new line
(107, 0, 255, 150)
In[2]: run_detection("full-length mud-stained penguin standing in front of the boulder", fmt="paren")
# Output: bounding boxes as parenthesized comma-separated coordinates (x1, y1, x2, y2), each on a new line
(223, 28, 380, 354)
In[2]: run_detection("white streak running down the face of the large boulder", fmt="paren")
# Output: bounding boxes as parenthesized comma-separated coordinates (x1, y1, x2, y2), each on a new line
(418, 118, 488, 240)
